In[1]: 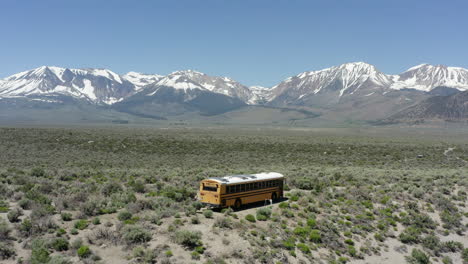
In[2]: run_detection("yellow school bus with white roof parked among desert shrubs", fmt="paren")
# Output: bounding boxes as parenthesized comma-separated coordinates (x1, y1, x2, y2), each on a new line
(199, 172, 284, 209)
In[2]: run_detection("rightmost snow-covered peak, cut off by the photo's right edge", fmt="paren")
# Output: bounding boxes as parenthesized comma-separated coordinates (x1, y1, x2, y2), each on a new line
(390, 64, 468, 92)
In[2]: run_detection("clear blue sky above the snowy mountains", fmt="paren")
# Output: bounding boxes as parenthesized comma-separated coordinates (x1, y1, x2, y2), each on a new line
(0, 0, 468, 86)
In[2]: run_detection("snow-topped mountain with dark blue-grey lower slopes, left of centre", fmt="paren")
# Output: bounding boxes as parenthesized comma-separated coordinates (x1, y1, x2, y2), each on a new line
(114, 70, 252, 116)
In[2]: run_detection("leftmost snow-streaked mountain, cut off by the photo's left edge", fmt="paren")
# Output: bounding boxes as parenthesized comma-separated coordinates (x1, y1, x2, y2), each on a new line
(0, 66, 135, 104)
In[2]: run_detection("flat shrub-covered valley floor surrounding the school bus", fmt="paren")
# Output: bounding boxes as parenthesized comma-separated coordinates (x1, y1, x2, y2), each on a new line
(0, 126, 468, 263)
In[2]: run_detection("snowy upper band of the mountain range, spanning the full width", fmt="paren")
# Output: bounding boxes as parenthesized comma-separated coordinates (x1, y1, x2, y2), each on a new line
(0, 62, 468, 104)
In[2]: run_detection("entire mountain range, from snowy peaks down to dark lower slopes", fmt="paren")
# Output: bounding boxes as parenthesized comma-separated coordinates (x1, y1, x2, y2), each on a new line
(0, 62, 468, 125)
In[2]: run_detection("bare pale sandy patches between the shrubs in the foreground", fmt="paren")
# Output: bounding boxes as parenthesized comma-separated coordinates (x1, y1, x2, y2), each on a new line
(0, 191, 468, 264)
